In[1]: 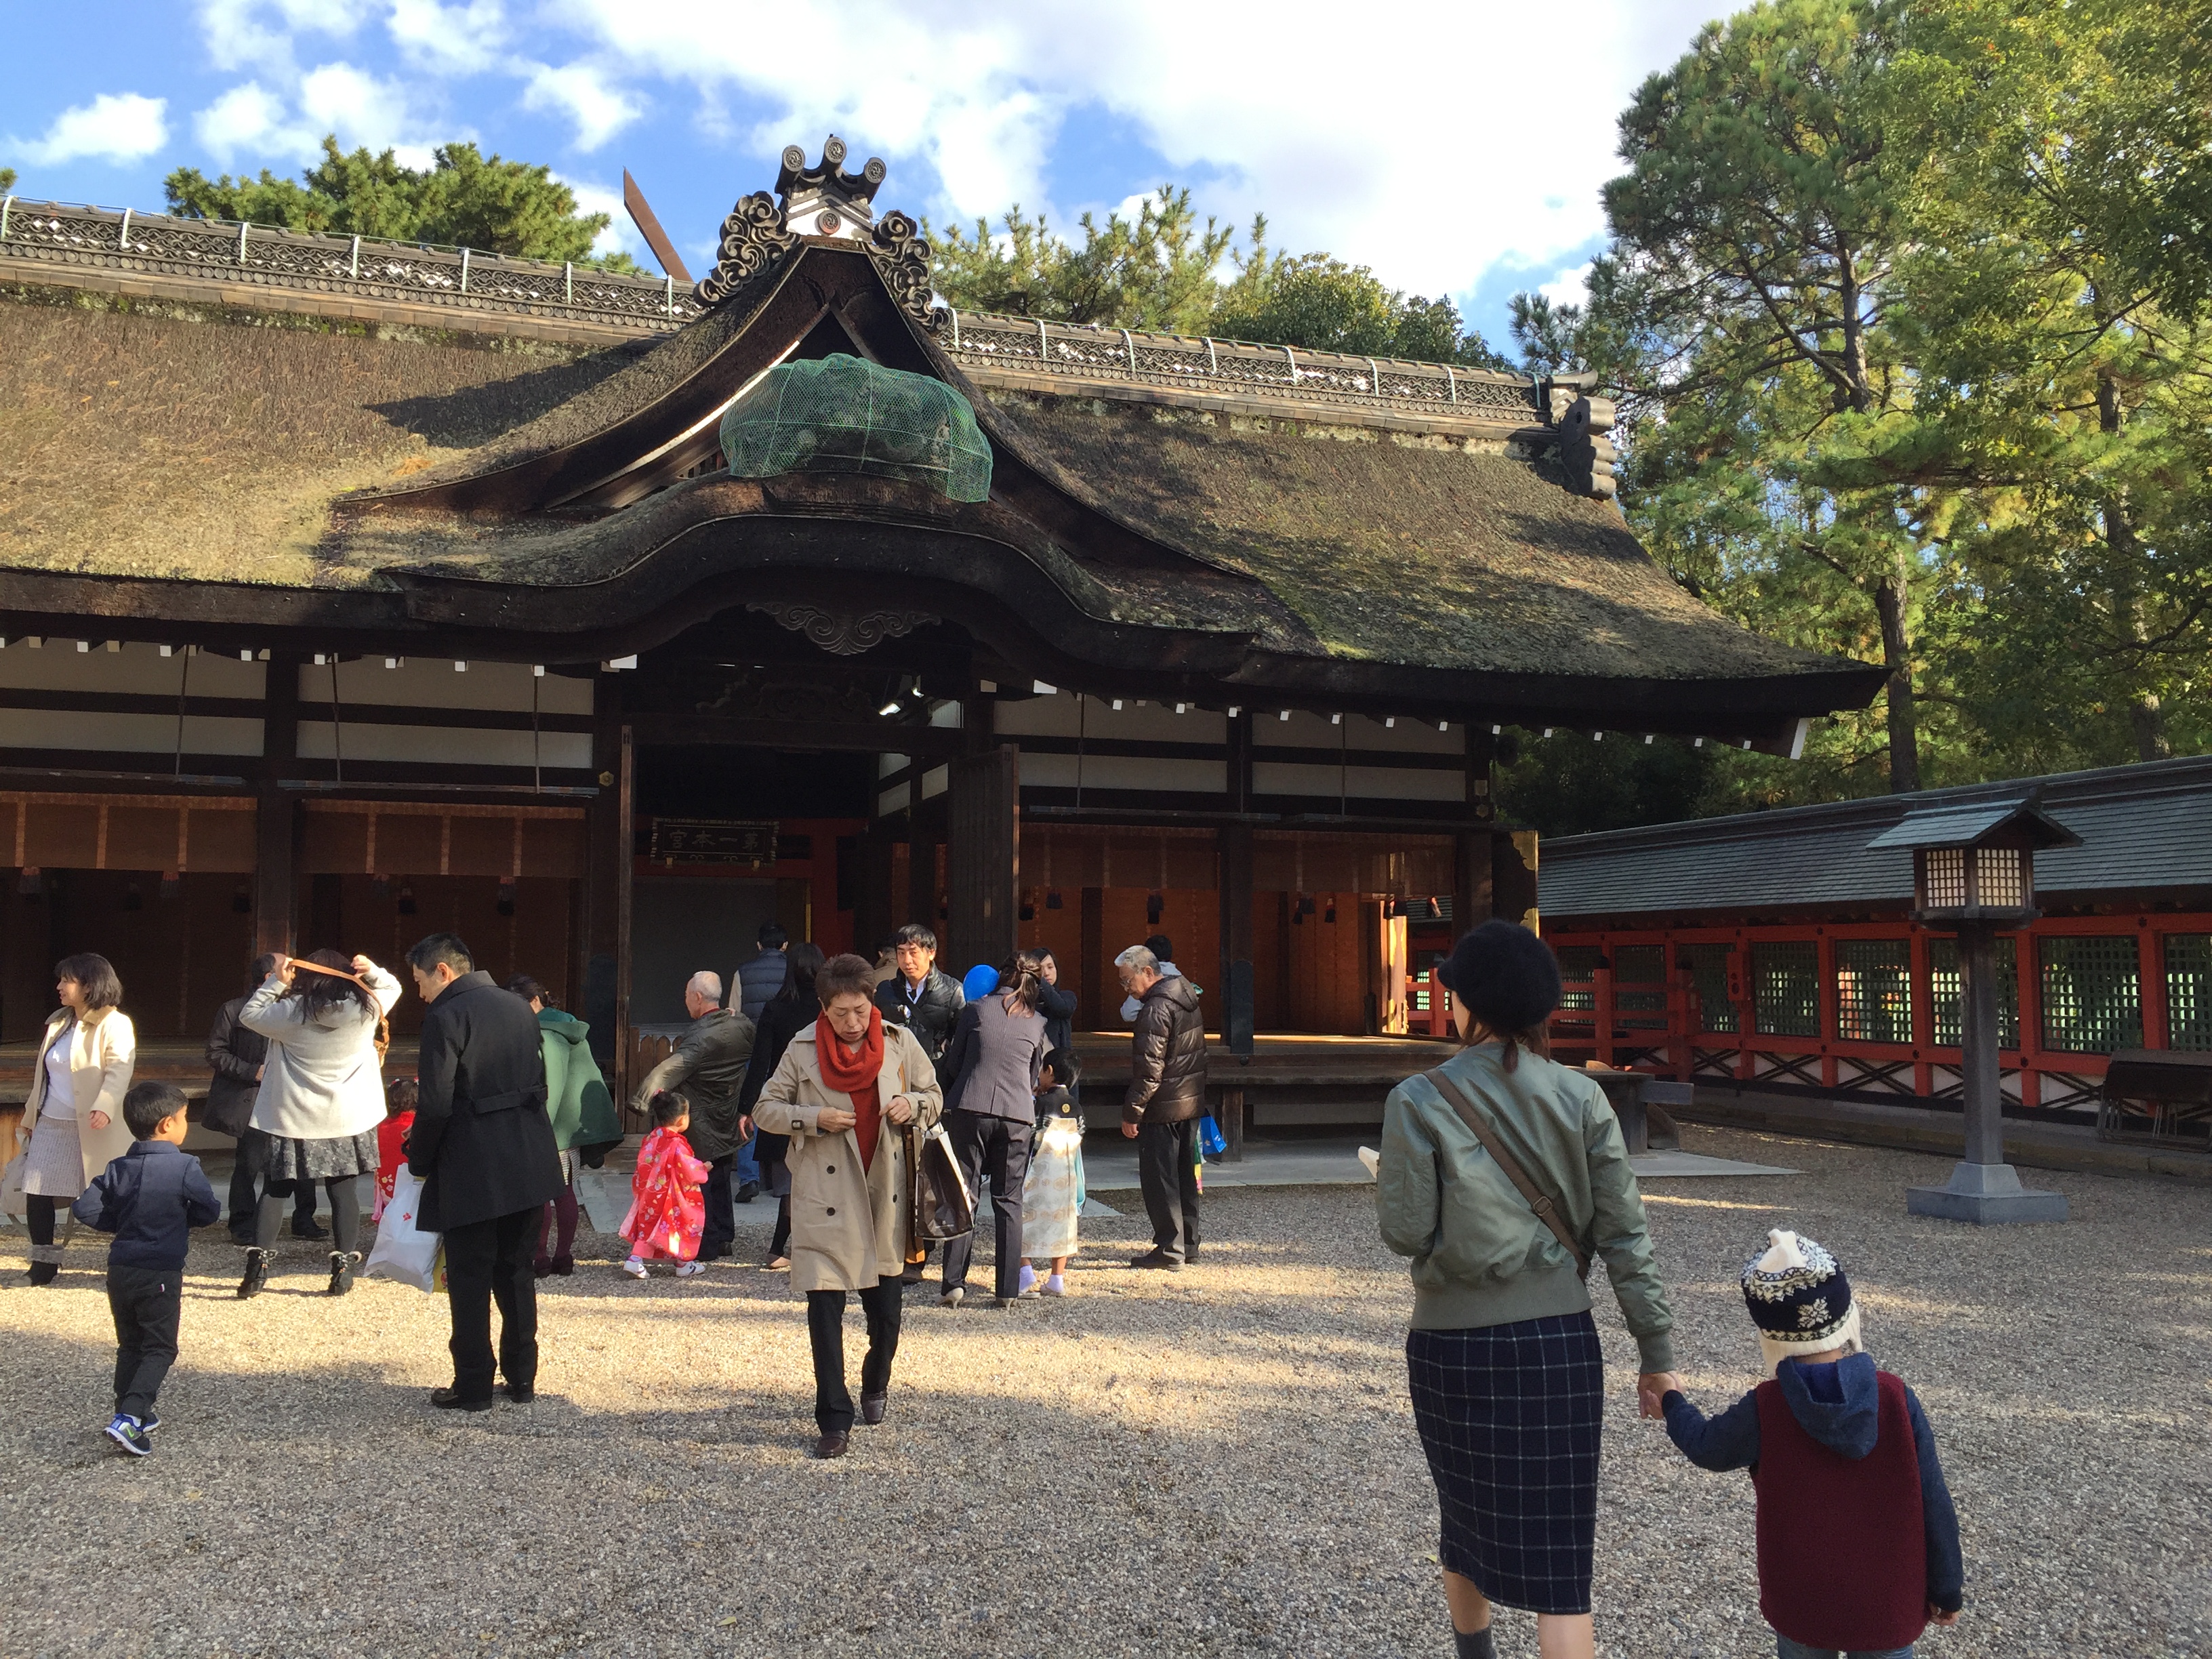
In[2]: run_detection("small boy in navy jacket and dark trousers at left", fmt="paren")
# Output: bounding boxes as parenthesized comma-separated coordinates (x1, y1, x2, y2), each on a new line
(70, 1084, 224, 1458)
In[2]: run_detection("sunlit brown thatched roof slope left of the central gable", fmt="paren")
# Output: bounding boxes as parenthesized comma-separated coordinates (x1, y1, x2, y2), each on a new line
(0, 287, 635, 586)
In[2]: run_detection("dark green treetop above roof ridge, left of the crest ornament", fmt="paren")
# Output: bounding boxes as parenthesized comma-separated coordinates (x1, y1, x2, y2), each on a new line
(164, 137, 619, 270)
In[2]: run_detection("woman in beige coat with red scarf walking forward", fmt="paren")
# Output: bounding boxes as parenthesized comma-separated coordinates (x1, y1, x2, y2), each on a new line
(754, 956, 945, 1458)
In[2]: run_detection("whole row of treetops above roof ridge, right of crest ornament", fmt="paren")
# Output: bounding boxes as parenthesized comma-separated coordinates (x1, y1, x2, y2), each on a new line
(929, 184, 1509, 369)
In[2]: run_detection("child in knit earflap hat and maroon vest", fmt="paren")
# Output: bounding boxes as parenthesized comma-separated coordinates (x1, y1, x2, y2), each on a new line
(1661, 1232, 1962, 1659)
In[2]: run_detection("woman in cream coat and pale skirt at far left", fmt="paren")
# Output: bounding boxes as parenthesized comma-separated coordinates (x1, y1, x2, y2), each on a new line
(22, 956, 137, 1285)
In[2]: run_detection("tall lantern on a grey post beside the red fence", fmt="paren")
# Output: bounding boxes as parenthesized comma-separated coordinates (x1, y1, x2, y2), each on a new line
(1867, 801, 2081, 1225)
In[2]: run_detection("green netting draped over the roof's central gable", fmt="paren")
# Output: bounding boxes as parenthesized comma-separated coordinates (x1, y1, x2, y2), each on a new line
(721, 352, 991, 502)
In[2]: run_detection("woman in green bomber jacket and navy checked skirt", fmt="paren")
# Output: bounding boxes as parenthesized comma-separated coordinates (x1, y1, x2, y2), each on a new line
(1376, 922, 1675, 1659)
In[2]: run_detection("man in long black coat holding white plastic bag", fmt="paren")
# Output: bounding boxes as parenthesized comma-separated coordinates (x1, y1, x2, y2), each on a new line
(407, 933, 564, 1411)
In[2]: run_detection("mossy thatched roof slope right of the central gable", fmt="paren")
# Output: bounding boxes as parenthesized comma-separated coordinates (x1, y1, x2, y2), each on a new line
(978, 392, 1843, 679)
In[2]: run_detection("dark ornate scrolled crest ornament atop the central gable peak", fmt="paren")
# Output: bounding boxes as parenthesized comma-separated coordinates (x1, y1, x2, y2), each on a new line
(695, 133, 945, 329)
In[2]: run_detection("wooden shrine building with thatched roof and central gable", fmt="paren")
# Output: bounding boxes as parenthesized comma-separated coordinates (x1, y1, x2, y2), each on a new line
(0, 140, 1880, 1119)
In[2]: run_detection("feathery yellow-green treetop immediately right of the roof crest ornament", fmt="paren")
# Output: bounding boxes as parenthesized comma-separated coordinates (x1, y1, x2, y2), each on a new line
(924, 186, 1234, 334)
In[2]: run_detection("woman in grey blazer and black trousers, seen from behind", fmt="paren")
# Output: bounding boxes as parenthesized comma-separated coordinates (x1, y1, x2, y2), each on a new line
(942, 954, 1046, 1307)
